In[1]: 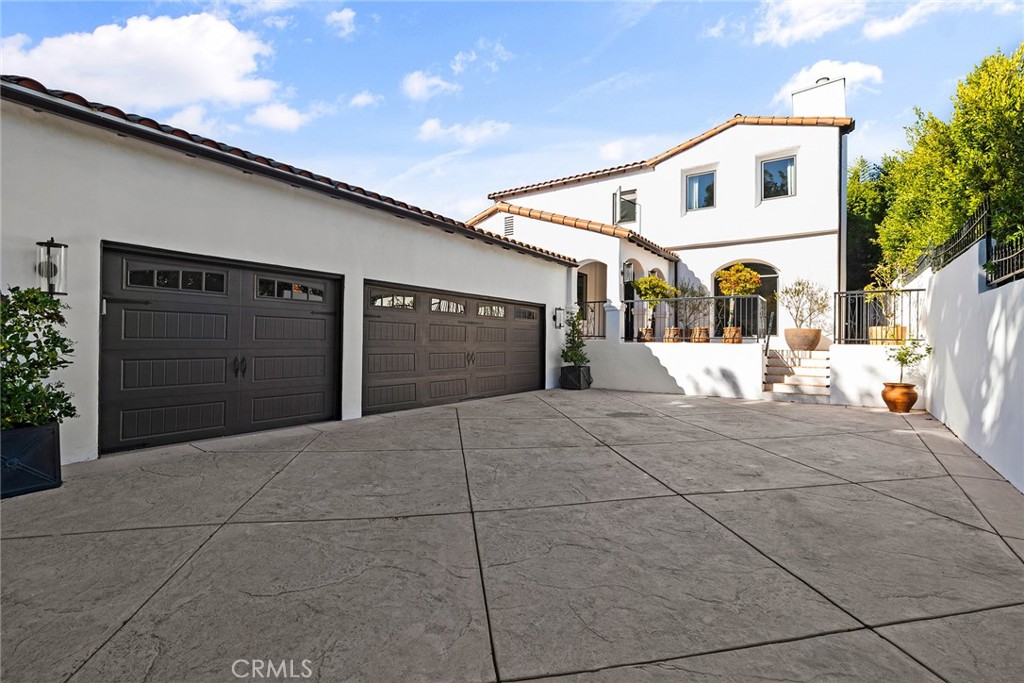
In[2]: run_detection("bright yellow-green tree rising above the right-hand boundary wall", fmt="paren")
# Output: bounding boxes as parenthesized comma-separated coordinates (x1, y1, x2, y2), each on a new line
(876, 43, 1024, 281)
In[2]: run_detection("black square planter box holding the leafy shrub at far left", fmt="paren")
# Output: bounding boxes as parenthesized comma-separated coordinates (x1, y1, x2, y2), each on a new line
(0, 422, 61, 498)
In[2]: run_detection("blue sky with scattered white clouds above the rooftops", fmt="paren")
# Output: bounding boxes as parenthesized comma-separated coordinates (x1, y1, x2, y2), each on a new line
(0, 0, 1024, 219)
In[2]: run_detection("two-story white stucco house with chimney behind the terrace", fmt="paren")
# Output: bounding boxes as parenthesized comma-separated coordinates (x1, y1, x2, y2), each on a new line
(467, 79, 854, 338)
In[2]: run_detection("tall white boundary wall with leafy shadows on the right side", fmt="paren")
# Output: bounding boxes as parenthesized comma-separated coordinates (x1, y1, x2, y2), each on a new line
(925, 242, 1024, 490)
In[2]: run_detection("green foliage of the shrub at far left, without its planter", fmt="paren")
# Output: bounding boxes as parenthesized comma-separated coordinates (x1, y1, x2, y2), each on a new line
(0, 287, 78, 429)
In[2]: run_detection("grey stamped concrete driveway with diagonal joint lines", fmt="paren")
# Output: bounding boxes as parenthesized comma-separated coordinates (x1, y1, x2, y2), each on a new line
(2, 391, 1024, 683)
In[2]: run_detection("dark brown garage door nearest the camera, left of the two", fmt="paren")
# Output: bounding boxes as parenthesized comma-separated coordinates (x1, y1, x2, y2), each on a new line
(99, 248, 341, 452)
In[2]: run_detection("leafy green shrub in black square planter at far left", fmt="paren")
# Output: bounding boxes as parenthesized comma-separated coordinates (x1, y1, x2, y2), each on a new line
(0, 287, 78, 498)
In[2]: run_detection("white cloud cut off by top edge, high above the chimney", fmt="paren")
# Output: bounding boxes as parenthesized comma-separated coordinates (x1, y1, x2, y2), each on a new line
(754, 0, 867, 47)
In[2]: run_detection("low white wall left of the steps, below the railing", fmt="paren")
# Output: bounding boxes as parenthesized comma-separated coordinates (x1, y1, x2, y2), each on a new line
(587, 339, 764, 399)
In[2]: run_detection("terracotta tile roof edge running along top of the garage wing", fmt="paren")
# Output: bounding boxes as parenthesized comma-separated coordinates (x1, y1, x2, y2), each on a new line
(0, 76, 577, 265)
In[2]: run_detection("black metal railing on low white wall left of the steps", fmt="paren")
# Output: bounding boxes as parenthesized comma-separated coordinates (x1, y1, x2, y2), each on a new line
(623, 295, 768, 342)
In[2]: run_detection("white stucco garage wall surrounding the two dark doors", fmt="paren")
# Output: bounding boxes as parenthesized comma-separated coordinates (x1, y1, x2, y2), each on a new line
(0, 101, 570, 462)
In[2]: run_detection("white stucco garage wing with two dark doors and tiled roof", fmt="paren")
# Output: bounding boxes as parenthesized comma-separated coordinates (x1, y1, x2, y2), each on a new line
(0, 76, 577, 462)
